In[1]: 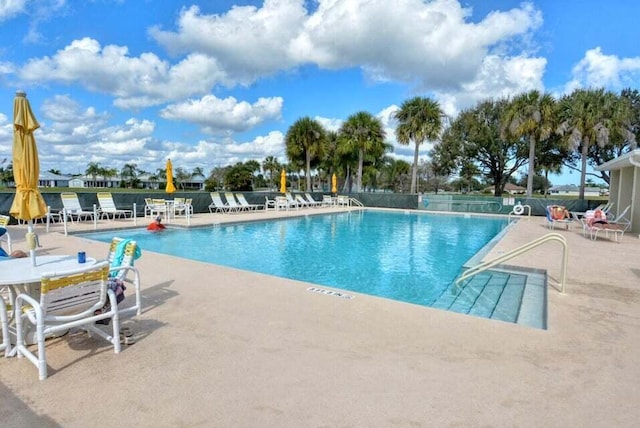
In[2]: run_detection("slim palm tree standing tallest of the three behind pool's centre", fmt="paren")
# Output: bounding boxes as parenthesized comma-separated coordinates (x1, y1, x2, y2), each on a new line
(393, 97, 444, 193)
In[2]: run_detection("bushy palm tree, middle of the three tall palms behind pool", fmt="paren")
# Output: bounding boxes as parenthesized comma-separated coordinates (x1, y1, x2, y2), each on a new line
(339, 111, 386, 192)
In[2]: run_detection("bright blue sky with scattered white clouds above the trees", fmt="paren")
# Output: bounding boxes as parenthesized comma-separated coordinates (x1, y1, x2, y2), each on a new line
(0, 0, 640, 184)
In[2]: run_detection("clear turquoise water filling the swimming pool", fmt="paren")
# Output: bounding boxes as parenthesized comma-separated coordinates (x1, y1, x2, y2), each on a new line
(80, 210, 507, 306)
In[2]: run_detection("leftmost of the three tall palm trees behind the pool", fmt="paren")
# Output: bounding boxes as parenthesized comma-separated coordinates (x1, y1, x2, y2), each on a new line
(285, 117, 326, 192)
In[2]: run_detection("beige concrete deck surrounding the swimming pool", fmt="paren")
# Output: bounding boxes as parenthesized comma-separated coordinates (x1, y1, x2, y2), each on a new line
(0, 209, 640, 427)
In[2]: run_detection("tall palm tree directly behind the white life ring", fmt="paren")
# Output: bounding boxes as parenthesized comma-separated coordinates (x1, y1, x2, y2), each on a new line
(503, 90, 555, 197)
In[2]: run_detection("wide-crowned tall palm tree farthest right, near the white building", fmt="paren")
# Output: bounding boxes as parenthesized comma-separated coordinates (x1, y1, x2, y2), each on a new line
(558, 89, 635, 199)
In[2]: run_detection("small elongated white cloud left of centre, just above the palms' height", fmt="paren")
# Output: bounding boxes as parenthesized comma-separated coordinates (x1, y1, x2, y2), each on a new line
(160, 95, 283, 133)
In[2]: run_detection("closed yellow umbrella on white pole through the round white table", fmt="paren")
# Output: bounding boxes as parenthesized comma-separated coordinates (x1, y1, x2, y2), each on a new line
(9, 91, 47, 266)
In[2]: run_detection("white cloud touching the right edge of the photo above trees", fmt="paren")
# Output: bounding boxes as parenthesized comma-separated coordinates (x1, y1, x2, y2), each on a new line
(565, 47, 640, 93)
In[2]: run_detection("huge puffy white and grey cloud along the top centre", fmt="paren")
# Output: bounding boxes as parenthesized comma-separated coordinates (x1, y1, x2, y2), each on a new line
(150, 0, 542, 89)
